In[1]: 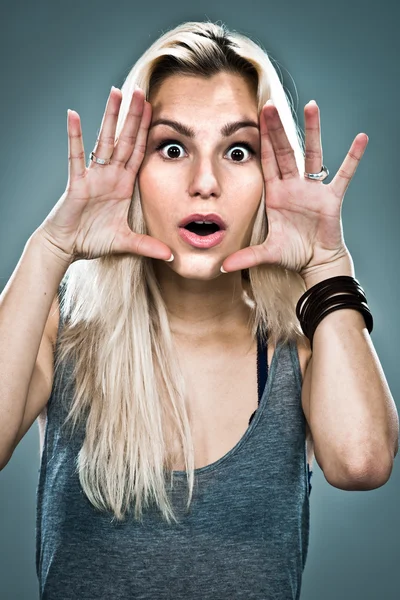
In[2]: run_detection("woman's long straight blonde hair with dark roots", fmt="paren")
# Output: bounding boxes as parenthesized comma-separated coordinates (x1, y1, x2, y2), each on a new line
(56, 22, 305, 523)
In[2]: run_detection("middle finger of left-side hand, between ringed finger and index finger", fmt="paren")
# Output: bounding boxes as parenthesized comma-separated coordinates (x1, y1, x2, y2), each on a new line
(112, 88, 145, 167)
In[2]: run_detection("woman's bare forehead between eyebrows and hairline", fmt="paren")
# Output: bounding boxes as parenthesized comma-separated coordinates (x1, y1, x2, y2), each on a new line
(150, 72, 258, 117)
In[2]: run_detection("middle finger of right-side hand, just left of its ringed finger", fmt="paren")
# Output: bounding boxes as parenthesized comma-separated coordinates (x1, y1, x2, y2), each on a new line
(264, 105, 299, 179)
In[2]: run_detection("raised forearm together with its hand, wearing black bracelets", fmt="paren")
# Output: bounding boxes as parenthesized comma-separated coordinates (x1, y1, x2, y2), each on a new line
(217, 99, 399, 489)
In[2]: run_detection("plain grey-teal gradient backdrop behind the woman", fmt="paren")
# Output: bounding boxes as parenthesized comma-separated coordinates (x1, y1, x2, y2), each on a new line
(0, 0, 400, 600)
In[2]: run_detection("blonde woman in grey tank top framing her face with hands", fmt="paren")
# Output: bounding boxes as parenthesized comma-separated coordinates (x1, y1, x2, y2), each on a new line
(0, 22, 398, 600)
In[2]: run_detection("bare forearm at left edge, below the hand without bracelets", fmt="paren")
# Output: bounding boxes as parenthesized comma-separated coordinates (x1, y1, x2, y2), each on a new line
(0, 232, 68, 468)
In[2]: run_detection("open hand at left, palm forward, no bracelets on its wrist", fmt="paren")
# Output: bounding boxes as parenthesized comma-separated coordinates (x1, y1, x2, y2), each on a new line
(35, 88, 172, 262)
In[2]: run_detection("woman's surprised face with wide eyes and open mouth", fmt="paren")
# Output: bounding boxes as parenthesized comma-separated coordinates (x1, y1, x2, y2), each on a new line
(138, 73, 263, 280)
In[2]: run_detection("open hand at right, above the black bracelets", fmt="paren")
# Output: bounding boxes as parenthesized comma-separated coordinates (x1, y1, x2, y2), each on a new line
(223, 102, 368, 279)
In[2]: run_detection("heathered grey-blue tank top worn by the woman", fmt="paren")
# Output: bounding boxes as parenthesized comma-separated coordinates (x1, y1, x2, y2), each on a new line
(36, 296, 310, 600)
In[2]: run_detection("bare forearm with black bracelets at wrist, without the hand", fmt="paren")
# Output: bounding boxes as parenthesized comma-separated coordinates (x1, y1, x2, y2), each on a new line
(302, 251, 399, 490)
